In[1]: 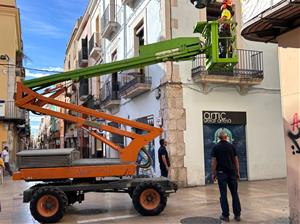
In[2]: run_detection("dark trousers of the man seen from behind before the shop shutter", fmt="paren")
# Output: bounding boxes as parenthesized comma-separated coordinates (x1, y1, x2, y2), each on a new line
(217, 171, 241, 217)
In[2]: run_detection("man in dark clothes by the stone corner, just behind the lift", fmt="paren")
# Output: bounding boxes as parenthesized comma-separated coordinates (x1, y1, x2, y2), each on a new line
(158, 139, 170, 177)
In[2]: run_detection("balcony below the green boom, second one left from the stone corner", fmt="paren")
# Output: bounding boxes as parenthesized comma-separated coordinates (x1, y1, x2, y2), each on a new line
(100, 81, 120, 110)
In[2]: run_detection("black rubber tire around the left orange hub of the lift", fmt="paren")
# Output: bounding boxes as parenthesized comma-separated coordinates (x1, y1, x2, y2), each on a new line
(30, 187, 68, 223)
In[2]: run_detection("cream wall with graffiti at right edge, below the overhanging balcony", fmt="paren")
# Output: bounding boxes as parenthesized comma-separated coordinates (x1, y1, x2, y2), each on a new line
(278, 28, 300, 224)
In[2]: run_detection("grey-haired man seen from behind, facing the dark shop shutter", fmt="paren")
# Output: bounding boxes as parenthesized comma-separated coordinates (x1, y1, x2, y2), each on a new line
(211, 131, 241, 222)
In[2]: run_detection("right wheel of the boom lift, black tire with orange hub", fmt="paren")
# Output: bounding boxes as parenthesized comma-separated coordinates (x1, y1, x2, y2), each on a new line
(132, 182, 167, 216)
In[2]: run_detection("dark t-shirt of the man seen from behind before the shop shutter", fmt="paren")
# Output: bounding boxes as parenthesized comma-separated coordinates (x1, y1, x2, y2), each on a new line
(211, 140, 237, 174)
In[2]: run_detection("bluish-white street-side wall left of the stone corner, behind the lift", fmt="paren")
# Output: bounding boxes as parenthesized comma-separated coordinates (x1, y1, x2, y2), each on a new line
(101, 0, 164, 174)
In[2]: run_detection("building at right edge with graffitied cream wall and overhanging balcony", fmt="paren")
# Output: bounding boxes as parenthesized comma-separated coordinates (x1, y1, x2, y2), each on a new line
(242, 0, 300, 223)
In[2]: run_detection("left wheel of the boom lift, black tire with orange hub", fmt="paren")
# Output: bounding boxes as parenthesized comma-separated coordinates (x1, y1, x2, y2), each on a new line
(30, 187, 68, 223)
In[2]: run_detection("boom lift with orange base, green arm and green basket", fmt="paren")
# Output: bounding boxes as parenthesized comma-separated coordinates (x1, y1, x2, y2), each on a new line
(13, 4, 237, 223)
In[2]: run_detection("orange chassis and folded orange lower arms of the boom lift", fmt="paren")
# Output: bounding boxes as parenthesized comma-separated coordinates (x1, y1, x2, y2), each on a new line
(13, 83, 162, 181)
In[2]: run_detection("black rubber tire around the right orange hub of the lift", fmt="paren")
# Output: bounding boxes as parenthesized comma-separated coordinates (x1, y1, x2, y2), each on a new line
(132, 182, 167, 216)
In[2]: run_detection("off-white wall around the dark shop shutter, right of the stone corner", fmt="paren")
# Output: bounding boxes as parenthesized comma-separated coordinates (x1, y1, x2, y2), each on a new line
(173, 1, 286, 186)
